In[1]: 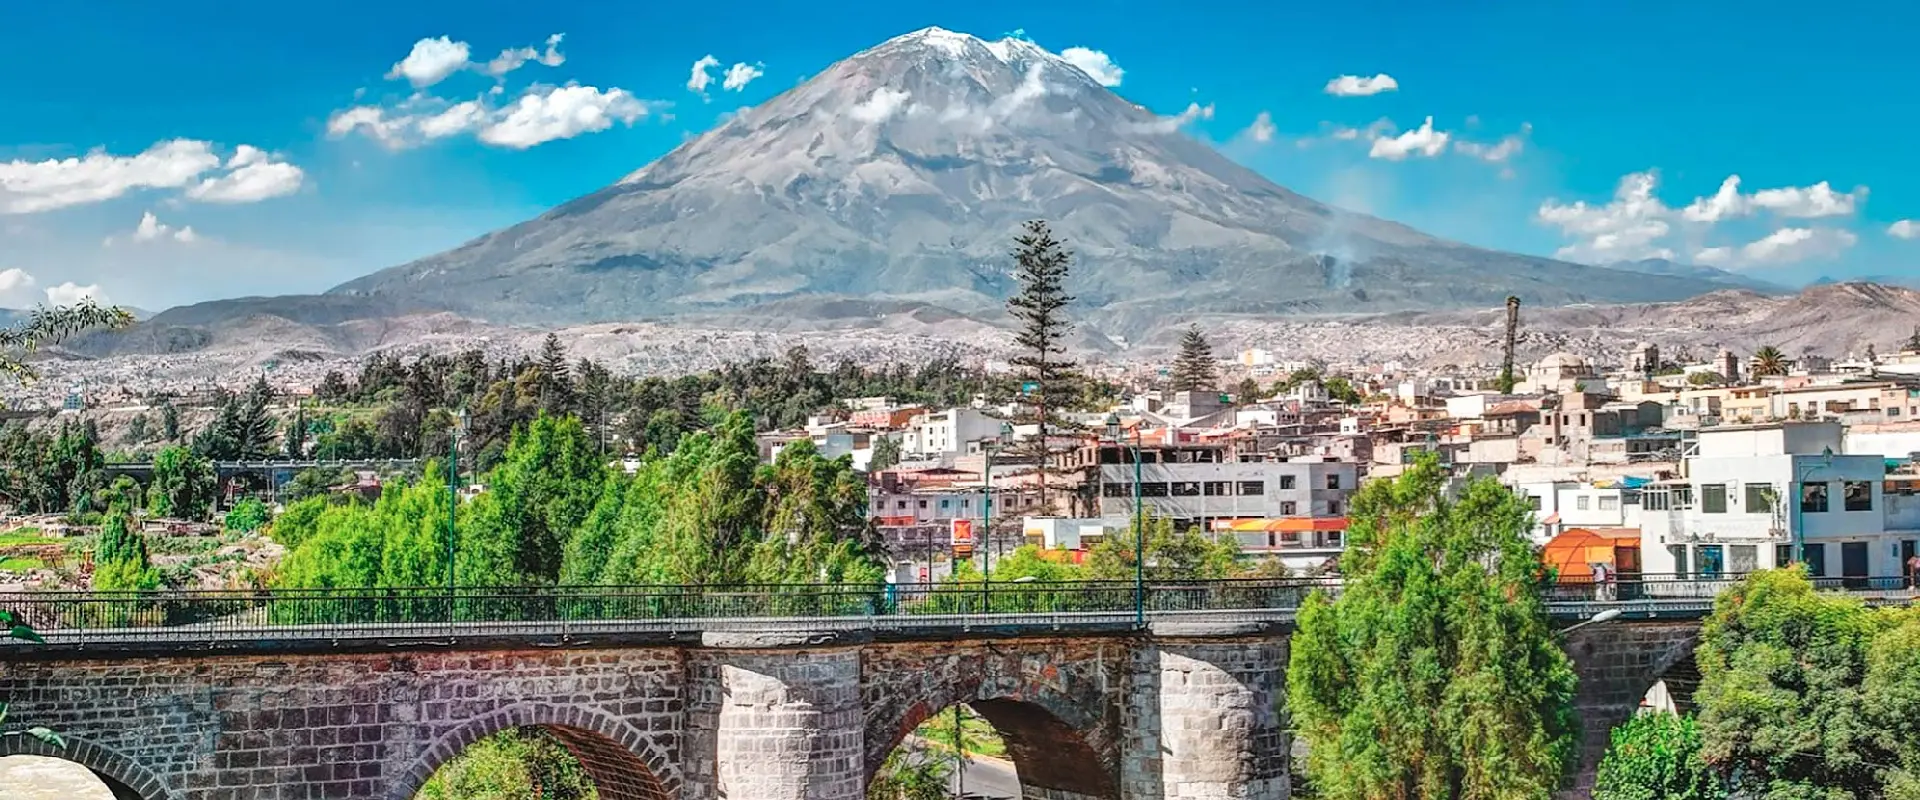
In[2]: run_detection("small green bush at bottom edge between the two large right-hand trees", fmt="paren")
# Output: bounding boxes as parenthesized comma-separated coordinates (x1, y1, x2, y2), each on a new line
(1594, 712, 1726, 800)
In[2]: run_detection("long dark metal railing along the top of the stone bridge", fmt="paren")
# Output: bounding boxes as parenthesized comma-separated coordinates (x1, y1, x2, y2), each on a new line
(0, 576, 1914, 647)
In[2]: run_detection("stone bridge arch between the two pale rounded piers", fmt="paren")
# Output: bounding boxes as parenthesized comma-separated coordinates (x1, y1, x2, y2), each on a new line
(864, 643, 1119, 800)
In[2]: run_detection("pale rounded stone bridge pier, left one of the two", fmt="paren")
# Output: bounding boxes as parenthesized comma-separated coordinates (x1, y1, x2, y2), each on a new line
(682, 641, 866, 800)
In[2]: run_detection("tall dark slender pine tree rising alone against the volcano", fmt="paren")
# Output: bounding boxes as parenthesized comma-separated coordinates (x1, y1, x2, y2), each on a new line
(1006, 219, 1081, 506)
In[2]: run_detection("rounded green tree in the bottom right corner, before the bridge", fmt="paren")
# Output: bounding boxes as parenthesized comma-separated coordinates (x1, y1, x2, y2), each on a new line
(1693, 568, 1920, 798)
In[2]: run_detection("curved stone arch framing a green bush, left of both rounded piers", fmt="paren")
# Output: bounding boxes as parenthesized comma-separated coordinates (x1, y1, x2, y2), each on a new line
(386, 702, 680, 800)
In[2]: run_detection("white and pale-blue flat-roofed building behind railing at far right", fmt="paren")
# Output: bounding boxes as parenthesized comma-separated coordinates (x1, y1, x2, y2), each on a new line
(1640, 422, 1920, 577)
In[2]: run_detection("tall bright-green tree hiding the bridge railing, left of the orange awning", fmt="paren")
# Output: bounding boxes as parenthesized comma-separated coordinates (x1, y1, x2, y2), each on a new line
(1288, 459, 1578, 800)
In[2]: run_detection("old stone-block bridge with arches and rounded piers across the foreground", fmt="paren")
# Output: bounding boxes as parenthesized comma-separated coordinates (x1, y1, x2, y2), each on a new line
(0, 620, 1697, 800)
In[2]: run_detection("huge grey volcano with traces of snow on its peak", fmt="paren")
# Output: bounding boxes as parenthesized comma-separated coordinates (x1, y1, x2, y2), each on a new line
(334, 29, 1728, 330)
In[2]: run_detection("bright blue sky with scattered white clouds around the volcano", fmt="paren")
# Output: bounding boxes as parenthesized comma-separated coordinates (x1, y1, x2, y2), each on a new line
(0, 0, 1920, 307)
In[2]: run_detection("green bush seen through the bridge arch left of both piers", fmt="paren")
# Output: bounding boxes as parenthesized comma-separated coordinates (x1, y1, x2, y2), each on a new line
(415, 727, 599, 800)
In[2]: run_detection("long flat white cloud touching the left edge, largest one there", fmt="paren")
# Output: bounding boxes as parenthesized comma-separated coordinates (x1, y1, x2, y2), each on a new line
(0, 138, 221, 213)
